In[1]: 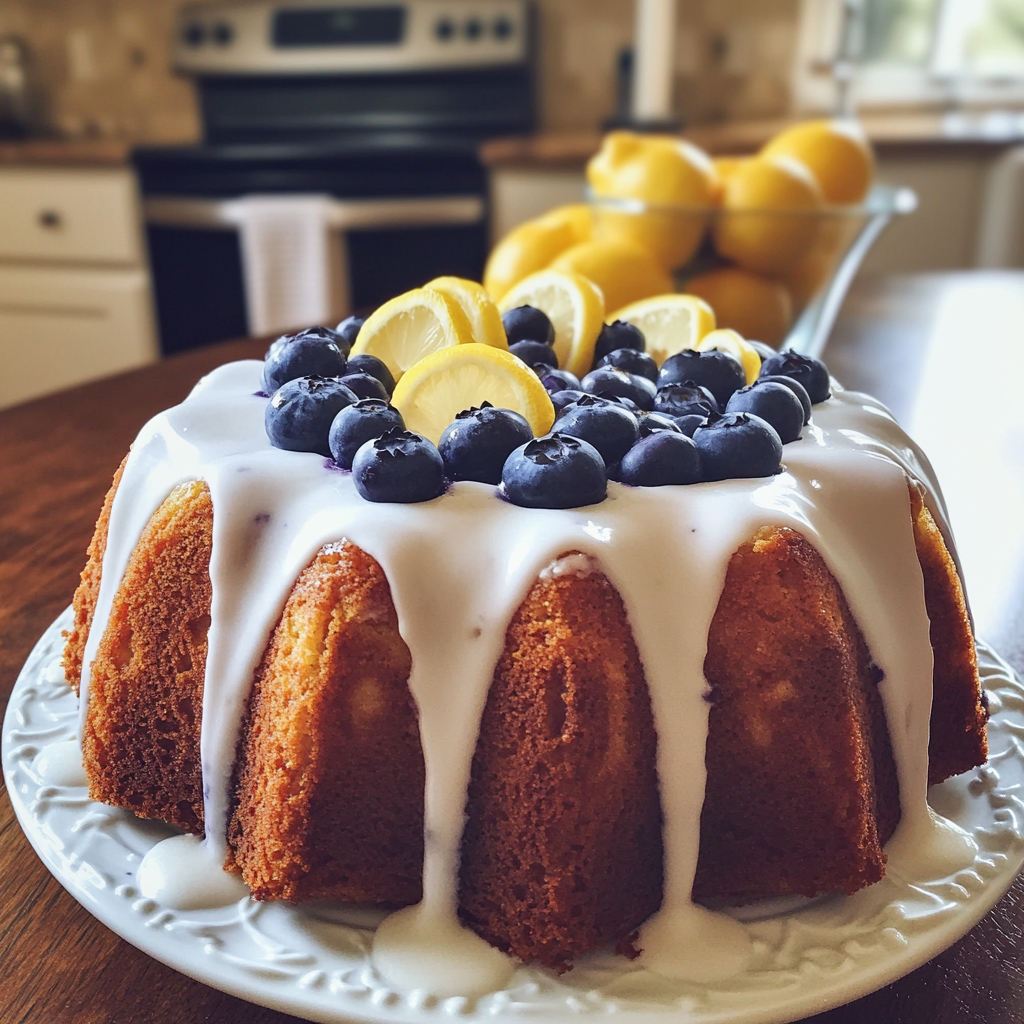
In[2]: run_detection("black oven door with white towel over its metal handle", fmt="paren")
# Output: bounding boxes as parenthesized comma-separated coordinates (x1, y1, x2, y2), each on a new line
(133, 142, 488, 353)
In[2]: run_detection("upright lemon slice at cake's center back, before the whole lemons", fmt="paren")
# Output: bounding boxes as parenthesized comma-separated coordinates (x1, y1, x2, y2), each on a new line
(498, 270, 604, 377)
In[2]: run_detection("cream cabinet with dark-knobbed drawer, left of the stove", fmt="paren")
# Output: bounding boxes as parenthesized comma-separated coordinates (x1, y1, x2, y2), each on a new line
(0, 167, 159, 407)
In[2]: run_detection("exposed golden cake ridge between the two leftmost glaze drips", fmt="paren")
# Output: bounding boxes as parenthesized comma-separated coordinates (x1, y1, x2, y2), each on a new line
(80, 481, 213, 833)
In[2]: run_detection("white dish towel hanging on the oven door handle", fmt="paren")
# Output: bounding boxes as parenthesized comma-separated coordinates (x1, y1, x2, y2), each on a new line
(231, 195, 347, 335)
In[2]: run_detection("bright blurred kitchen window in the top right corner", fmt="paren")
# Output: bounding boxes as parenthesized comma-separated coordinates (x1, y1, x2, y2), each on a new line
(795, 0, 1024, 110)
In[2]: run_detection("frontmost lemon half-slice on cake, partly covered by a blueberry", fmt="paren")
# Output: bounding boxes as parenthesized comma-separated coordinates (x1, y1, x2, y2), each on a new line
(391, 344, 555, 444)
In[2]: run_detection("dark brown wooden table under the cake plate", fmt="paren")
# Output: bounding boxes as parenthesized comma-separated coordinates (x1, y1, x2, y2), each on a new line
(0, 272, 1024, 1024)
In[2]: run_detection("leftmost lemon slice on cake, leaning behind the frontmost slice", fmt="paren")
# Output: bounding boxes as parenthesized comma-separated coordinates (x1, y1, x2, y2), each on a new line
(351, 288, 473, 380)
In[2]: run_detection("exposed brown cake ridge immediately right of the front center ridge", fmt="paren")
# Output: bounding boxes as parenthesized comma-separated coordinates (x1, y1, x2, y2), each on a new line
(694, 527, 899, 902)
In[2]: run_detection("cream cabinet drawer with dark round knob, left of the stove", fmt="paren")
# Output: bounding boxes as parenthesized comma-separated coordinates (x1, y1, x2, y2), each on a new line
(0, 168, 142, 263)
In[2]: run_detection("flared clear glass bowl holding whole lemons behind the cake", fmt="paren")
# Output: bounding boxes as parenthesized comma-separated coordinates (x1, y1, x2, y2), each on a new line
(587, 184, 918, 356)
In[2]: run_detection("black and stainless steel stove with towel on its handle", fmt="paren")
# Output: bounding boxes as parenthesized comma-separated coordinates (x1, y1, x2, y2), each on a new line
(140, 0, 536, 352)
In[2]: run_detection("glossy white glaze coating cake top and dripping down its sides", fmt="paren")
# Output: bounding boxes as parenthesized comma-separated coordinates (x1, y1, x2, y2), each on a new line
(75, 361, 970, 991)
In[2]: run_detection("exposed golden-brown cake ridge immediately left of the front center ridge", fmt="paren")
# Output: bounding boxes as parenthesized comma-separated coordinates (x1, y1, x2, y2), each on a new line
(228, 542, 424, 904)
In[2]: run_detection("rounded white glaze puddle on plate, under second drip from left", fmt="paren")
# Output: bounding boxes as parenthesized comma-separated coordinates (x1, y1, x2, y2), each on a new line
(136, 836, 249, 910)
